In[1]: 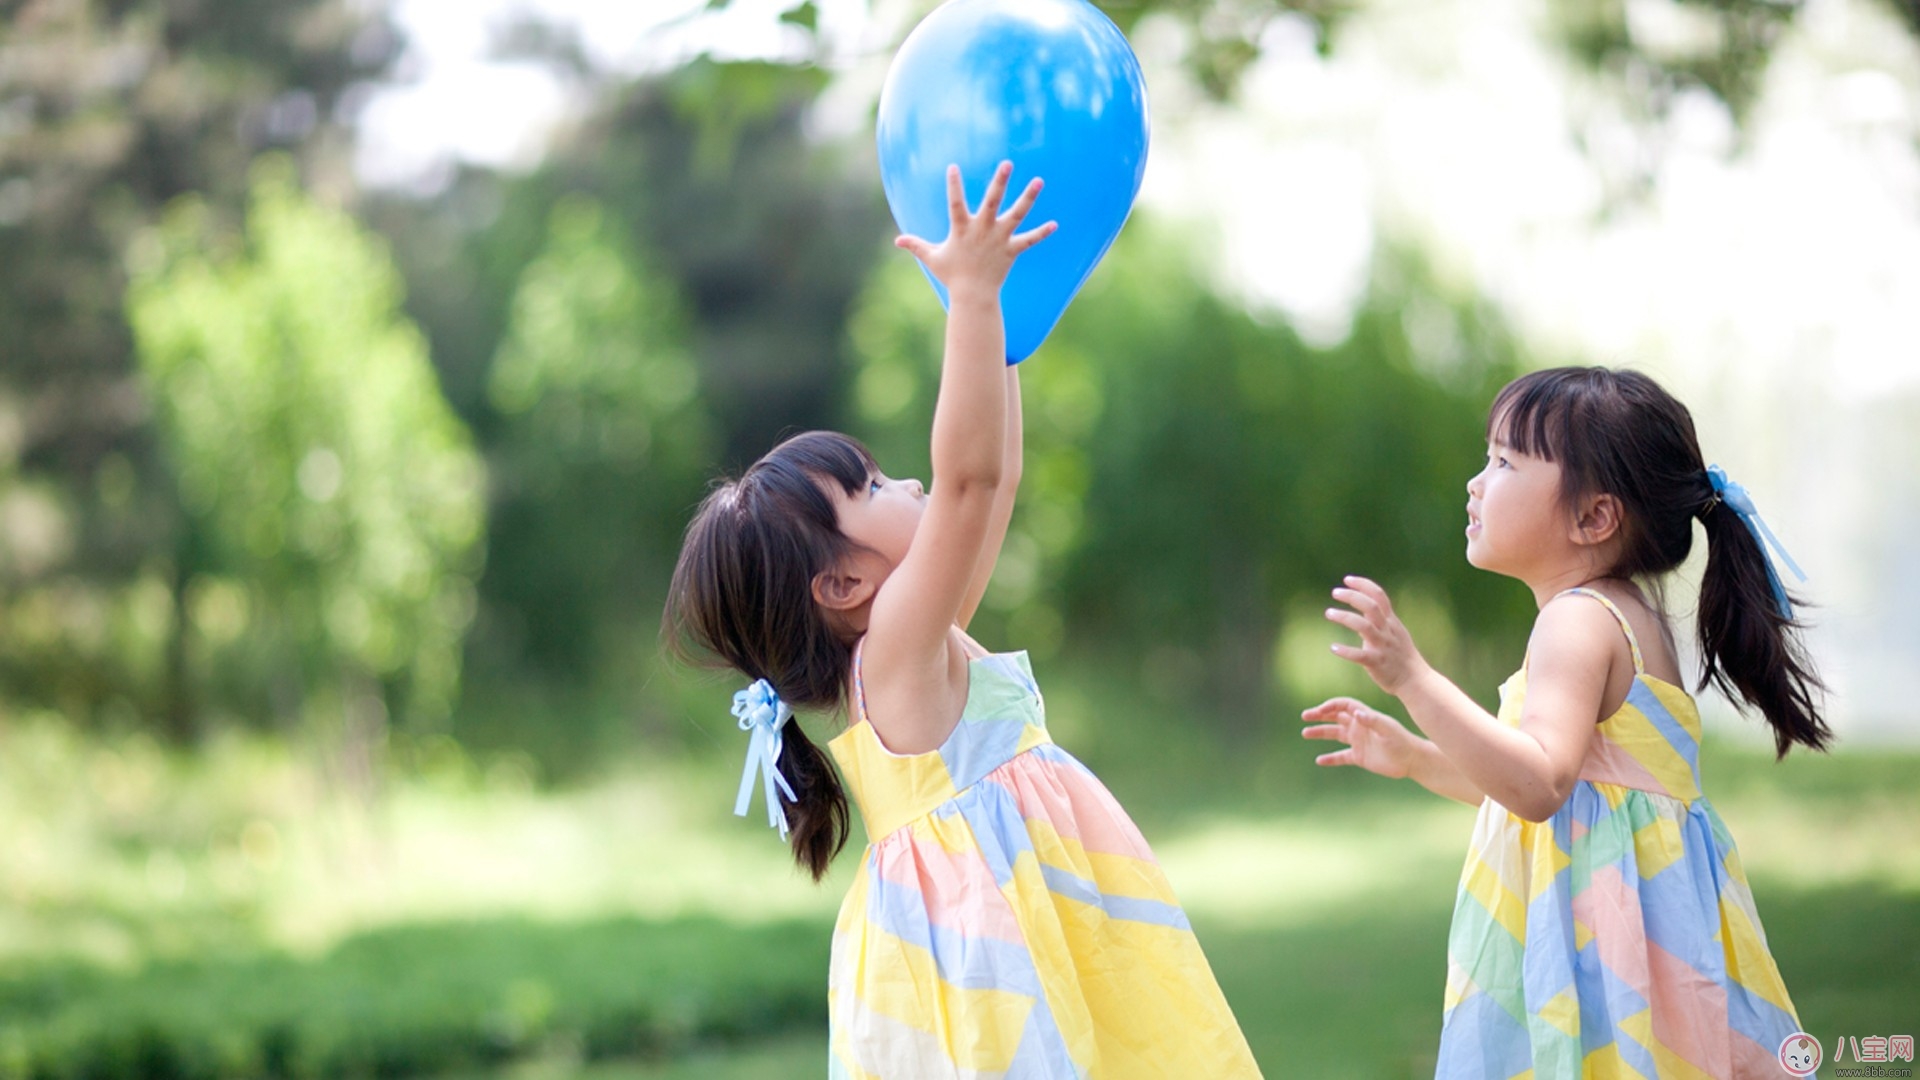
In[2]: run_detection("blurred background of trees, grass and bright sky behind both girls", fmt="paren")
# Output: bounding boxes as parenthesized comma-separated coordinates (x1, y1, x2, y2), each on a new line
(0, 0, 1920, 1078)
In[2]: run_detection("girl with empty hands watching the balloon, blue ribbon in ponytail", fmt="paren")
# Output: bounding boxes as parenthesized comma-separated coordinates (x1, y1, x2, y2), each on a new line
(1302, 367, 1832, 1080)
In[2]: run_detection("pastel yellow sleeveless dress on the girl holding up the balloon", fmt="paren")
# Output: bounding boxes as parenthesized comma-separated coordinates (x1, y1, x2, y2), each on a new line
(828, 634, 1260, 1080)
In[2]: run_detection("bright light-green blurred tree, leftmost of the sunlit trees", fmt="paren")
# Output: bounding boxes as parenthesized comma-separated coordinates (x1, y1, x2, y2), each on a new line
(127, 161, 482, 721)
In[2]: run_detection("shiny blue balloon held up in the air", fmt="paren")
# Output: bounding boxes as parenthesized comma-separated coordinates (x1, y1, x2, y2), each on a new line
(877, 0, 1146, 363)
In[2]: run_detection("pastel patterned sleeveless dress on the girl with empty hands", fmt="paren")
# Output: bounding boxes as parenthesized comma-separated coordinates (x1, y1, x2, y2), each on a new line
(1436, 588, 1799, 1080)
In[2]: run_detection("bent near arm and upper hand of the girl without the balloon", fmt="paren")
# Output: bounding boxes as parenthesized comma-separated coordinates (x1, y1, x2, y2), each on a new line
(1327, 577, 1619, 821)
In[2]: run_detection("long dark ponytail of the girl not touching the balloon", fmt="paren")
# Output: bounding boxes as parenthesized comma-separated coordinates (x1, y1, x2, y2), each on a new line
(1697, 498, 1834, 757)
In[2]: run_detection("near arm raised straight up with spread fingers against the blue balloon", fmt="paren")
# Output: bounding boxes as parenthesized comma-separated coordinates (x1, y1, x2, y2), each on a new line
(864, 163, 1054, 753)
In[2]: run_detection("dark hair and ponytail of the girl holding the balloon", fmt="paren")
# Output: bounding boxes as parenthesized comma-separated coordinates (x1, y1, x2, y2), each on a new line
(662, 430, 877, 880)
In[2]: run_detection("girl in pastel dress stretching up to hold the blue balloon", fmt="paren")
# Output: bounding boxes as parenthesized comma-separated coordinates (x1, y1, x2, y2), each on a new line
(668, 163, 1260, 1080)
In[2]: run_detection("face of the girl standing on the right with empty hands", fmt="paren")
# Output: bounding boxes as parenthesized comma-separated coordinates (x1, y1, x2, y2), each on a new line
(1467, 432, 1571, 580)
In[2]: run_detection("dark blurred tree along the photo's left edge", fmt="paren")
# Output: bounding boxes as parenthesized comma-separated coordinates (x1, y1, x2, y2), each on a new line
(0, 0, 397, 734)
